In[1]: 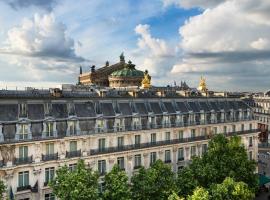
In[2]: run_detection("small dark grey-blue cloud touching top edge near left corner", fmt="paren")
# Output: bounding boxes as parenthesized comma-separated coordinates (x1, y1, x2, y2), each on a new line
(2, 0, 56, 11)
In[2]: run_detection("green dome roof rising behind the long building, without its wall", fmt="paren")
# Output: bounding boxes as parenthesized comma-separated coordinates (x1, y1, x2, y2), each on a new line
(111, 61, 144, 77)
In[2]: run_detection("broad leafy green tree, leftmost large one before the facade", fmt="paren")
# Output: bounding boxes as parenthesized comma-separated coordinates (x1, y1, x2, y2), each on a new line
(49, 160, 99, 200)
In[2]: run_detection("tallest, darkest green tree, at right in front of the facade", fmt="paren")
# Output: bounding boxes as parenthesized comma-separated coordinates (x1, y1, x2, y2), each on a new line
(177, 134, 258, 195)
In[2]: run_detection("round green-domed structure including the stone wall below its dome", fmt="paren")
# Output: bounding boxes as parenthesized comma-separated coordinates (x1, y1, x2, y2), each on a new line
(109, 61, 144, 87)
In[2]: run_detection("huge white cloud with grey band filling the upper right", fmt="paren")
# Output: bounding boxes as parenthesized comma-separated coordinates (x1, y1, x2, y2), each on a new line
(171, 0, 270, 89)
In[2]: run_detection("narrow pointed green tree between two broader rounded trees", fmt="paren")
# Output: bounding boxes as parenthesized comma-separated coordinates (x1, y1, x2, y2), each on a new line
(103, 165, 131, 200)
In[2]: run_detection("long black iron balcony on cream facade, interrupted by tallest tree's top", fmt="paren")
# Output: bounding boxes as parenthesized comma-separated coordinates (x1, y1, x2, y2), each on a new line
(90, 129, 258, 155)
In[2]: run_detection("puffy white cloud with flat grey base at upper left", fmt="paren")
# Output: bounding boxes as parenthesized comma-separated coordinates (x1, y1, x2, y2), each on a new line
(1, 14, 84, 62)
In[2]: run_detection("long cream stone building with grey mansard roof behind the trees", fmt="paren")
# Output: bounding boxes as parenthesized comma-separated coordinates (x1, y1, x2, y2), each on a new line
(0, 87, 258, 200)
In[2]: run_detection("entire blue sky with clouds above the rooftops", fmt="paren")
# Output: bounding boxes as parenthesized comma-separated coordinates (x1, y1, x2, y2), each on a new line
(0, 0, 270, 91)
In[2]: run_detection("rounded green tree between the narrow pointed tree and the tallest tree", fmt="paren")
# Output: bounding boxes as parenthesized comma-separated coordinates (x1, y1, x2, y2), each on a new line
(131, 160, 176, 200)
